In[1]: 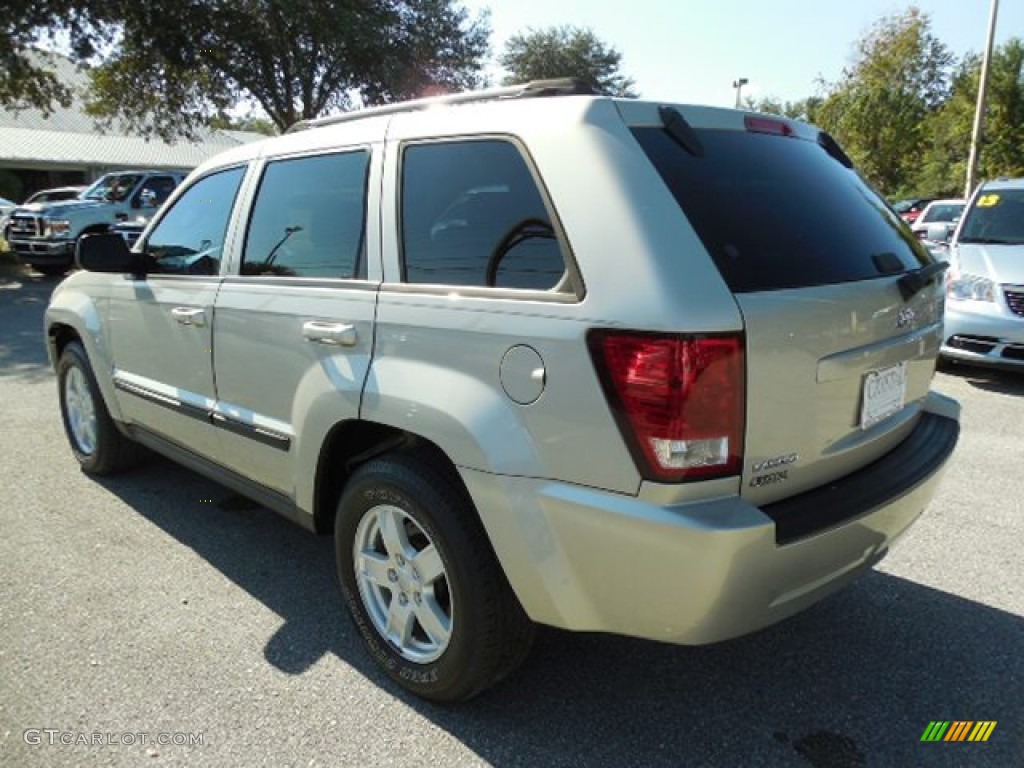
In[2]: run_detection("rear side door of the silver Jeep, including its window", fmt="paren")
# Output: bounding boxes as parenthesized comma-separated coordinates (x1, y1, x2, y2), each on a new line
(213, 145, 381, 501)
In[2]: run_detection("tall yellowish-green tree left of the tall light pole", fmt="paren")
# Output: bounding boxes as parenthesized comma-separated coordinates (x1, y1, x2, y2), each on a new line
(815, 6, 953, 196)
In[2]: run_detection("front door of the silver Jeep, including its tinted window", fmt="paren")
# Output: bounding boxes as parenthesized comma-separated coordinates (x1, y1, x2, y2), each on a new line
(110, 166, 246, 456)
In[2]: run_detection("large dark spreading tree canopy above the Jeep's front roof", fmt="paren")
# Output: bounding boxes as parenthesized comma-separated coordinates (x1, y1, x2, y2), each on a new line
(81, 0, 489, 137)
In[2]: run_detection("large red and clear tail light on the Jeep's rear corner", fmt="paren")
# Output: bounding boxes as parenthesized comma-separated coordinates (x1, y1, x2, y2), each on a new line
(589, 331, 745, 482)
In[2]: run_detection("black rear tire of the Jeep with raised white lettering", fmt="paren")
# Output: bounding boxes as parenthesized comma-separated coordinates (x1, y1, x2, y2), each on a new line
(335, 454, 535, 703)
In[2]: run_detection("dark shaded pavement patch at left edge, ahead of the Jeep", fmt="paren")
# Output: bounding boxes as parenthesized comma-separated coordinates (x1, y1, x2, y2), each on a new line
(0, 263, 60, 379)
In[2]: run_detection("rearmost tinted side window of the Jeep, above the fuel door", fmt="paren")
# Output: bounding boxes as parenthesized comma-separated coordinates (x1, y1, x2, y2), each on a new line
(401, 139, 571, 291)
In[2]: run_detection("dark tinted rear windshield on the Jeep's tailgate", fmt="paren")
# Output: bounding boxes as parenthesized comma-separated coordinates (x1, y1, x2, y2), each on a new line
(633, 127, 931, 293)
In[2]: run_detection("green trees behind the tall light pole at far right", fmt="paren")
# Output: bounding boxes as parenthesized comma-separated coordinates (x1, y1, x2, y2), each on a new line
(916, 38, 1024, 197)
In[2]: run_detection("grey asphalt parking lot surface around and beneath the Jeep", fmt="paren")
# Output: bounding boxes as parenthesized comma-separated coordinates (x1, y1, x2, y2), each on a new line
(0, 274, 1024, 768)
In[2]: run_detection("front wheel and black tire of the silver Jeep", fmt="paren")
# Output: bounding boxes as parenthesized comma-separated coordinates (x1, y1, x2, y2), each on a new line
(57, 341, 143, 475)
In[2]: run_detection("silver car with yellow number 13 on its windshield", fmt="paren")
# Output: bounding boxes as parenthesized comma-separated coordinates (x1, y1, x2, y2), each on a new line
(937, 178, 1024, 368)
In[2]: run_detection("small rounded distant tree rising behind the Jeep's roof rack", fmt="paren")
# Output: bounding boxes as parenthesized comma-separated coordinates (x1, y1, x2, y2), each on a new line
(498, 26, 637, 96)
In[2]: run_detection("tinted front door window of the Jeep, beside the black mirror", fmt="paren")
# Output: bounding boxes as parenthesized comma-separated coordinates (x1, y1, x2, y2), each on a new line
(145, 167, 246, 274)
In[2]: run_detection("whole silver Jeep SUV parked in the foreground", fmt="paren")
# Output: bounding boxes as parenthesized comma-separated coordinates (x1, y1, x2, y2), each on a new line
(46, 82, 958, 701)
